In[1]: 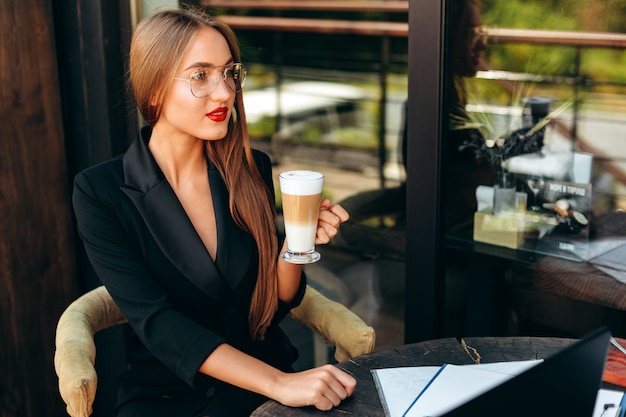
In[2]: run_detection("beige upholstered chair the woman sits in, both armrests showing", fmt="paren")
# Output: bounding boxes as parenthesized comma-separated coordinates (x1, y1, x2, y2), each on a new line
(54, 286, 376, 417)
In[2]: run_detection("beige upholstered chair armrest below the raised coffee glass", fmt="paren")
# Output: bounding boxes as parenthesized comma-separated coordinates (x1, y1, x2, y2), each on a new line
(290, 285, 376, 362)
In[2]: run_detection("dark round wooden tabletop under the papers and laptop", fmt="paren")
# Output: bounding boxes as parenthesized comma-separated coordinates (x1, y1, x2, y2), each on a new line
(250, 337, 576, 417)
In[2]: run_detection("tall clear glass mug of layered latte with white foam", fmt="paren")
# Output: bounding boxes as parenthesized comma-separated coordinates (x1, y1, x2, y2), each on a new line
(279, 170, 324, 264)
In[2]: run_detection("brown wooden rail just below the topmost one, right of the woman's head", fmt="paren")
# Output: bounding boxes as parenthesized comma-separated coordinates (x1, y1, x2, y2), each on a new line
(219, 16, 409, 37)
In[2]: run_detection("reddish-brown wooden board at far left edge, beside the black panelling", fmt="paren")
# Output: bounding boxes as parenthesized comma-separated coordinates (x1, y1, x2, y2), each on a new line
(0, 0, 78, 417)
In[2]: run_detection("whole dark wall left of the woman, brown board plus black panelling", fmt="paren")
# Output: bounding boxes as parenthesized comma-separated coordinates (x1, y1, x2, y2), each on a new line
(0, 0, 136, 417)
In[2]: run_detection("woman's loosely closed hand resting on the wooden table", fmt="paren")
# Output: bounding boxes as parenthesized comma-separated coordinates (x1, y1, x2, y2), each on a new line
(272, 365, 356, 411)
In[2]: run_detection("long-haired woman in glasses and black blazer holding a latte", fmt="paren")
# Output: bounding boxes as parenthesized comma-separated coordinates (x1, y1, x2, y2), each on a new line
(73, 10, 356, 417)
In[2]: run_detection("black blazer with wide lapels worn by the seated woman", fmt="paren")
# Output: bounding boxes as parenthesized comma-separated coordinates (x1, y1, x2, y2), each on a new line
(73, 127, 305, 416)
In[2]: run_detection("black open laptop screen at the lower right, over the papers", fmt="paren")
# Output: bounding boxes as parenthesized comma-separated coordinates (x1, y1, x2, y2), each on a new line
(443, 328, 611, 417)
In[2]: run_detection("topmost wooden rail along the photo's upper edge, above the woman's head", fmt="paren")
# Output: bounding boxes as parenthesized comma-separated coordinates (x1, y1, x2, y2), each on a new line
(200, 0, 409, 13)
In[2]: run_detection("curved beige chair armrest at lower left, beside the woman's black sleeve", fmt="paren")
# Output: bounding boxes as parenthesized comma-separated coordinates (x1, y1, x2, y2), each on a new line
(54, 286, 126, 417)
